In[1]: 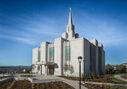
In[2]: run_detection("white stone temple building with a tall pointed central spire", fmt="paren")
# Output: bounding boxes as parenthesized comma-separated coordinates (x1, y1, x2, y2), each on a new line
(32, 8, 105, 76)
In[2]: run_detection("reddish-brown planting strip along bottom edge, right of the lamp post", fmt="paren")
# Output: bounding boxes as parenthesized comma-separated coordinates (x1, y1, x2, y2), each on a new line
(83, 83, 127, 89)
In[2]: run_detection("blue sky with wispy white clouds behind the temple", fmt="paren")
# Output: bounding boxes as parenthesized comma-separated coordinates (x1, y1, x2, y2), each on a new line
(0, 0, 127, 66)
